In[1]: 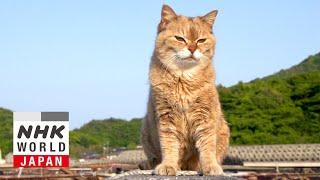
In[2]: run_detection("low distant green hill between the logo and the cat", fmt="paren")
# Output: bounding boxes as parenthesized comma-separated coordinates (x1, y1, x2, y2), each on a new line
(70, 118, 141, 155)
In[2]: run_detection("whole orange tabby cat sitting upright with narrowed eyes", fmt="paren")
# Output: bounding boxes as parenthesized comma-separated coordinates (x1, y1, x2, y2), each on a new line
(141, 5, 229, 175)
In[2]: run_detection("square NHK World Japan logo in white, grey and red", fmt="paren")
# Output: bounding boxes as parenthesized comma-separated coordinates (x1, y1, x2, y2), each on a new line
(13, 112, 69, 167)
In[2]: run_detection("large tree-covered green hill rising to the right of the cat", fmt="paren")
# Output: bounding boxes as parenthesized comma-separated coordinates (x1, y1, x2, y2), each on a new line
(219, 53, 320, 144)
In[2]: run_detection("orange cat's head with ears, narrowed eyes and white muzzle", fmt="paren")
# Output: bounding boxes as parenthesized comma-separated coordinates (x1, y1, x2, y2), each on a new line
(156, 5, 217, 71)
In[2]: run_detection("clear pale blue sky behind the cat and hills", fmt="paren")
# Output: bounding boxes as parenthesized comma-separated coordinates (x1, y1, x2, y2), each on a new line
(0, 0, 320, 128)
